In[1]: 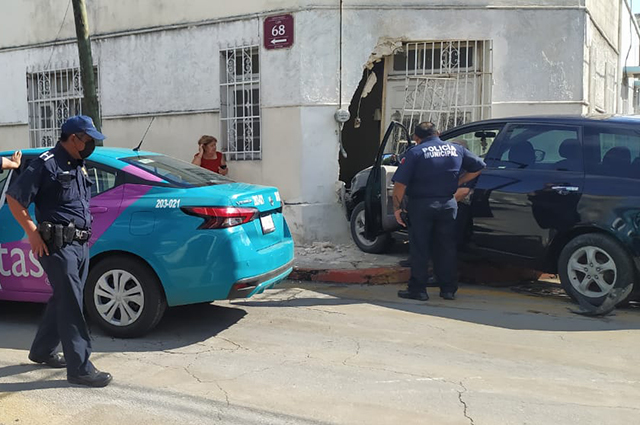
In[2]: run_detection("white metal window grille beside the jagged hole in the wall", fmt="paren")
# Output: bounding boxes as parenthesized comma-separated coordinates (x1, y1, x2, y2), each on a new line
(390, 40, 492, 130)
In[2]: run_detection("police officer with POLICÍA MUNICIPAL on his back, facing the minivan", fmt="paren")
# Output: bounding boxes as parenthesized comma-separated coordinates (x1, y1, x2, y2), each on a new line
(393, 122, 485, 301)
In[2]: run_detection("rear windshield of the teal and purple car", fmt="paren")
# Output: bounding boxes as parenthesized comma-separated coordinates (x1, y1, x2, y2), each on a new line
(123, 155, 233, 187)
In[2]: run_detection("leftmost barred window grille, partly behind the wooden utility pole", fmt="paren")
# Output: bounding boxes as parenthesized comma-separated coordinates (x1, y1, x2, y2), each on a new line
(27, 67, 100, 147)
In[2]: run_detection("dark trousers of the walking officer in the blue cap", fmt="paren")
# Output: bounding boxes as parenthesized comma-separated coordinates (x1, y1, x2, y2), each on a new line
(31, 242, 93, 376)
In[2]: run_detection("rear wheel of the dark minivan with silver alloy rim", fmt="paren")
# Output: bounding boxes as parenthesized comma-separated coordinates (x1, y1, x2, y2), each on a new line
(558, 233, 635, 306)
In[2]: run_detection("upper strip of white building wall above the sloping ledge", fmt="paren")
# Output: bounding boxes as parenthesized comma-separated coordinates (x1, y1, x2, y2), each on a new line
(0, 0, 584, 48)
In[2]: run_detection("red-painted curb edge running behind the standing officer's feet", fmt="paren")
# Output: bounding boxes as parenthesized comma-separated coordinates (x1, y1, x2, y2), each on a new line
(288, 263, 552, 286)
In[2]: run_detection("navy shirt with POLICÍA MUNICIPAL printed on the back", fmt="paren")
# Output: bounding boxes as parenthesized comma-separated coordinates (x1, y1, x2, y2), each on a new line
(393, 137, 485, 199)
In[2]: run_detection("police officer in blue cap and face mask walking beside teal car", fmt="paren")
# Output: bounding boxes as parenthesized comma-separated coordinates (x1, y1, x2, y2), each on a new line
(7, 115, 112, 387)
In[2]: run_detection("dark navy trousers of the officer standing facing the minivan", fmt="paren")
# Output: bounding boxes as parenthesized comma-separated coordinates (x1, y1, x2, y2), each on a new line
(409, 198, 458, 292)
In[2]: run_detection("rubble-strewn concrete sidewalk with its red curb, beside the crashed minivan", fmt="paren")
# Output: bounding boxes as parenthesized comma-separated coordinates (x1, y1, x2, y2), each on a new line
(290, 242, 551, 286)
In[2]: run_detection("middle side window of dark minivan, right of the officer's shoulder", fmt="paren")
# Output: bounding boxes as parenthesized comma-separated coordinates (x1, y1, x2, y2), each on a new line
(488, 124, 583, 172)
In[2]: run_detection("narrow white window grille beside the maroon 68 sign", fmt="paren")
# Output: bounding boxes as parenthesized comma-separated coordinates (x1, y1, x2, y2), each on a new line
(220, 45, 262, 161)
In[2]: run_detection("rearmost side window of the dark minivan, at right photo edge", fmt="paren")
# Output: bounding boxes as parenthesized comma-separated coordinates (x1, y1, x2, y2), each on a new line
(584, 127, 640, 179)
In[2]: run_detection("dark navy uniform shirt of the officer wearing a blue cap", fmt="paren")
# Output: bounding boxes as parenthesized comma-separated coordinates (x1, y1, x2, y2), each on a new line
(7, 143, 93, 229)
